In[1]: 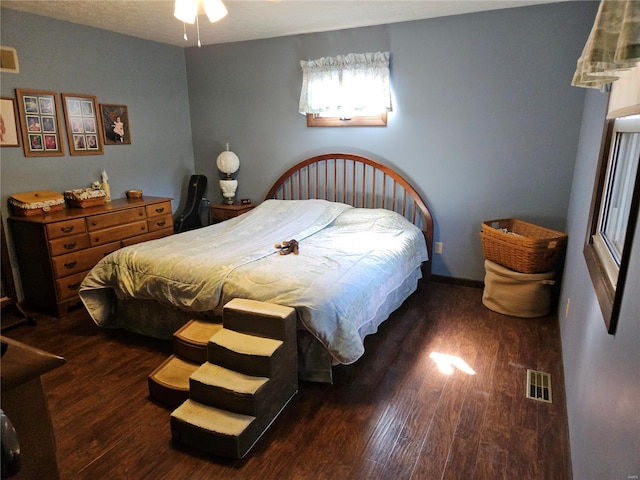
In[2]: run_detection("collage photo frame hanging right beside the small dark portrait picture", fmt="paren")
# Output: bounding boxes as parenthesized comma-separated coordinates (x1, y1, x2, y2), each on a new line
(62, 93, 104, 155)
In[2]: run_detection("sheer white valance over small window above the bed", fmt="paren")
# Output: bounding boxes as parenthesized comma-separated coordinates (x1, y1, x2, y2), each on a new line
(298, 52, 391, 116)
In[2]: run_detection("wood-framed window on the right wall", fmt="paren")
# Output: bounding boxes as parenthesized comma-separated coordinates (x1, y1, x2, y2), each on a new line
(584, 115, 640, 334)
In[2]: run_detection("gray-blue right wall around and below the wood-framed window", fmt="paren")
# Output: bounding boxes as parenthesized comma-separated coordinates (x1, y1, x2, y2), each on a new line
(559, 91, 640, 480)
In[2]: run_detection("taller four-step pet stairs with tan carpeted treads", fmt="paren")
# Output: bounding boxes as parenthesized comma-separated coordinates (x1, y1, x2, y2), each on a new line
(152, 299, 298, 458)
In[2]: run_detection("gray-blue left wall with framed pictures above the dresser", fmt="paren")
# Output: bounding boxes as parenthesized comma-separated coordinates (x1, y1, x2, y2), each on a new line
(0, 8, 193, 216)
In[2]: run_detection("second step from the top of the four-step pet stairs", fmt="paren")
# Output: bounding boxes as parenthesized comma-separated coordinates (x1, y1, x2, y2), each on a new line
(207, 328, 288, 377)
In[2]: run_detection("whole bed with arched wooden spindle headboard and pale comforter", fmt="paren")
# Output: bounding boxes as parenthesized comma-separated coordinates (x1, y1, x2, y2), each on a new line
(80, 154, 433, 383)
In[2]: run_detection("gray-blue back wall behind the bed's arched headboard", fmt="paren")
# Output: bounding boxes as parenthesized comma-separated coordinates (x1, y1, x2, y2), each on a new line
(186, 2, 597, 280)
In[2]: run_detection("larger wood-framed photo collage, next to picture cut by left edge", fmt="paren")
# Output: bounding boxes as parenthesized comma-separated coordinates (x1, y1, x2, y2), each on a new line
(16, 88, 64, 157)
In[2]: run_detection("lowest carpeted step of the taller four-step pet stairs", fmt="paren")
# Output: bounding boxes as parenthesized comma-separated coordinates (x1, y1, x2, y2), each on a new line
(171, 400, 263, 458)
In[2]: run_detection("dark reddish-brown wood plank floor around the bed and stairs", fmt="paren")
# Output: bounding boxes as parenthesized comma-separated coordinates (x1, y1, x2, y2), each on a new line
(3, 282, 571, 480)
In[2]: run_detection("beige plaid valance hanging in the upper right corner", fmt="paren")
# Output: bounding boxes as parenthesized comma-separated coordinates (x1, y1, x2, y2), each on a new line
(571, 0, 640, 88)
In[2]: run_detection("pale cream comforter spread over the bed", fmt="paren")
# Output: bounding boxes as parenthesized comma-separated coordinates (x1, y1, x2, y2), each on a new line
(80, 200, 427, 364)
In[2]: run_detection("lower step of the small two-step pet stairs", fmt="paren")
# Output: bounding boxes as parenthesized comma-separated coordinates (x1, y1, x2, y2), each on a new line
(148, 355, 200, 408)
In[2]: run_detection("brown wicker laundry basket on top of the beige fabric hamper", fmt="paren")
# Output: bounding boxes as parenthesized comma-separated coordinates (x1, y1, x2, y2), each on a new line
(480, 218, 567, 273)
